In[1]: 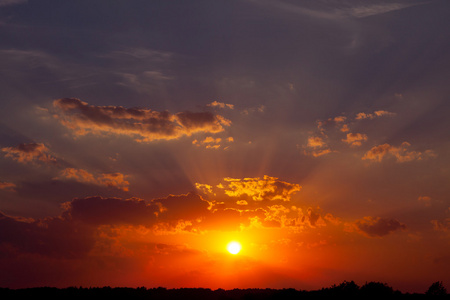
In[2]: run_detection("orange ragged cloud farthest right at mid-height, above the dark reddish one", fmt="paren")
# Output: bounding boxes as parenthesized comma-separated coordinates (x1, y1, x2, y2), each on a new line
(362, 142, 436, 163)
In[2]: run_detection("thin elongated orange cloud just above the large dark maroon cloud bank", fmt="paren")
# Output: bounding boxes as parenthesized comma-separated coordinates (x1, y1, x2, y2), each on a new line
(56, 168, 130, 191)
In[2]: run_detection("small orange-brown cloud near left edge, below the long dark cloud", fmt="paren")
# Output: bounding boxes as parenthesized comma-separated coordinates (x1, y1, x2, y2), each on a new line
(1, 143, 56, 164)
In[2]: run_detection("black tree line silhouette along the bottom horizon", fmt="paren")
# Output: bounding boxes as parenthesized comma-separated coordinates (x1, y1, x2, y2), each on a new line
(0, 281, 450, 300)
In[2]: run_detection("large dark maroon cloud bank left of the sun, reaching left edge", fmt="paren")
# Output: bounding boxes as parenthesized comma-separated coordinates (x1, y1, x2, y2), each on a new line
(0, 196, 165, 259)
